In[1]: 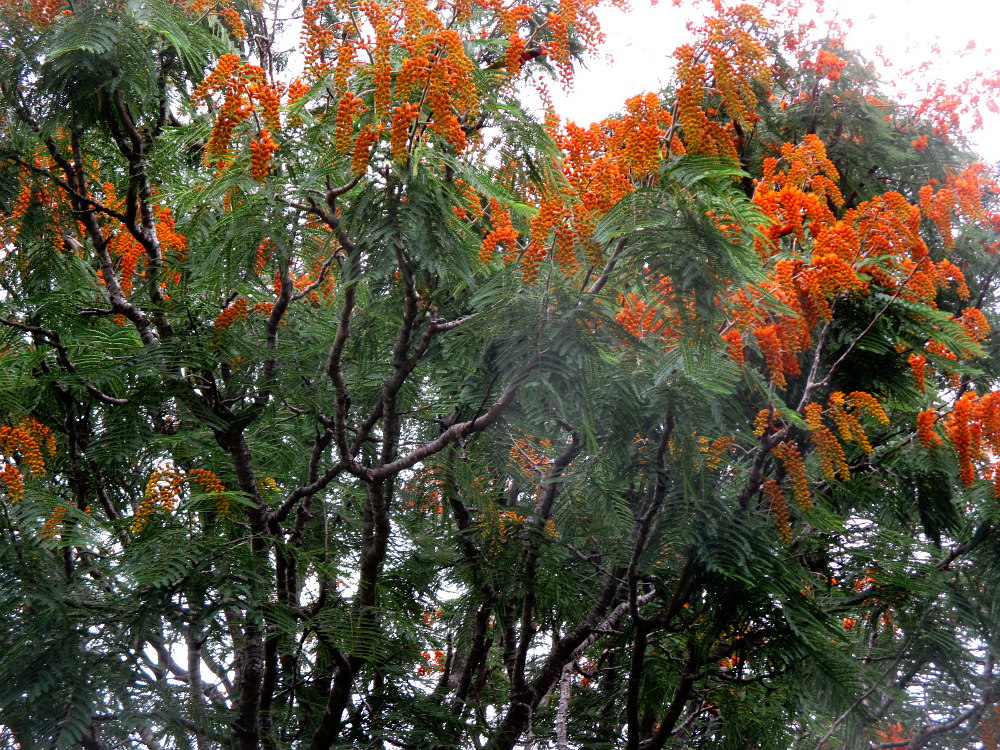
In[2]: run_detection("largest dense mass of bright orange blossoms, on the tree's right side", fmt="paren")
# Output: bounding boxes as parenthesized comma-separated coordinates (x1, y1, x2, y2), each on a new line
(712, 136, 944, 388)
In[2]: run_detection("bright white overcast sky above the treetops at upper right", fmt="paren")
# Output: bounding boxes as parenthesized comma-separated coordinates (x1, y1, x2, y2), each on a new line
(550, 0, 1000, 161)
